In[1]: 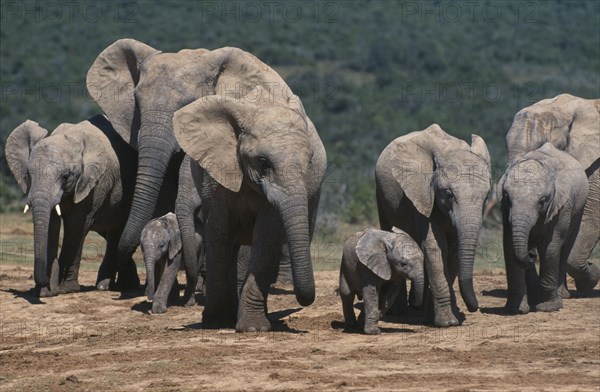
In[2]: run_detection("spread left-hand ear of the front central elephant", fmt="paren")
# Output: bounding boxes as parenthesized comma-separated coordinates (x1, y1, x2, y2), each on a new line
(173, 95, 257, 192)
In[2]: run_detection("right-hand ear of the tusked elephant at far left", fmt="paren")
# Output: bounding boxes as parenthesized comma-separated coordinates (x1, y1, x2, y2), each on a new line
(73, 119, 110, 203)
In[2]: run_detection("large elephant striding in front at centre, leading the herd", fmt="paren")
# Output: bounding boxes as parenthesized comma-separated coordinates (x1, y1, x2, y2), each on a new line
(173, 85, 327, 332)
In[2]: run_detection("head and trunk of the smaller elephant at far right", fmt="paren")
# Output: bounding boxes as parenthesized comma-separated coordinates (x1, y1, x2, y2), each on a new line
(498, 143, 588, 268)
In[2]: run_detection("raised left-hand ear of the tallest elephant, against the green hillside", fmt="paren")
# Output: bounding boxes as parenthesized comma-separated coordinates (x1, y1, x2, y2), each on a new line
(86, 38, 160, 148)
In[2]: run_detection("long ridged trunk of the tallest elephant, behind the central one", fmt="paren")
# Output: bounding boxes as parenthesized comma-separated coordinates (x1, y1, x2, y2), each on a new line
(119, 116, 177, 267)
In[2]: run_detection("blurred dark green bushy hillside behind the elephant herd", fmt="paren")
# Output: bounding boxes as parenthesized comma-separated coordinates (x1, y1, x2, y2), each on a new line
(0, 0, 600, 231)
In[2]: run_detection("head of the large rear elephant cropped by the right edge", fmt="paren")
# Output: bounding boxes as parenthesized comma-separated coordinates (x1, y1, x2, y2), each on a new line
(506, 94, 600, 169)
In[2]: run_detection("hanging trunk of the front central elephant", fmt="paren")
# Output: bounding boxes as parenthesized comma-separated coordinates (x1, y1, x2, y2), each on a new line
(276, 190, 315, 306)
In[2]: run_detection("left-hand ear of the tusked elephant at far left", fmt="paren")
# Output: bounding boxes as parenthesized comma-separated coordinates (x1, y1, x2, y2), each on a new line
(4, 120, 48, 194)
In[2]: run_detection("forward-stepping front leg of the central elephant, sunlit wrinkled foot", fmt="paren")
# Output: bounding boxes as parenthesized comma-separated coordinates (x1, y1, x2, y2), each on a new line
(235, 208, 283, 332)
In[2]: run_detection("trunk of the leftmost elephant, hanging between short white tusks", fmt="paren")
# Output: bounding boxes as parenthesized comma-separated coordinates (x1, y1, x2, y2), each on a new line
(31, 192, 60, 287)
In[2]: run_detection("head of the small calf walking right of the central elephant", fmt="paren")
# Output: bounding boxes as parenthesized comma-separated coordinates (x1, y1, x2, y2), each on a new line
(356, 228, 425, 306)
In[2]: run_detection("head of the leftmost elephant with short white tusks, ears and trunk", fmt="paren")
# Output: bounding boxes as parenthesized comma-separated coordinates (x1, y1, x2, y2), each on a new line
(5, 116, 119, 287)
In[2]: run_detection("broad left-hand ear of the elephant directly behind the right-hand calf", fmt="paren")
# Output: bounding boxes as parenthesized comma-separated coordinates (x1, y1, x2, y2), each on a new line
(390, 124, 448, 217)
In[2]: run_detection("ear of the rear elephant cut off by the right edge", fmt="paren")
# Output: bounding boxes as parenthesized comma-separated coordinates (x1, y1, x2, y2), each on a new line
(566, 99, 600, 170)
